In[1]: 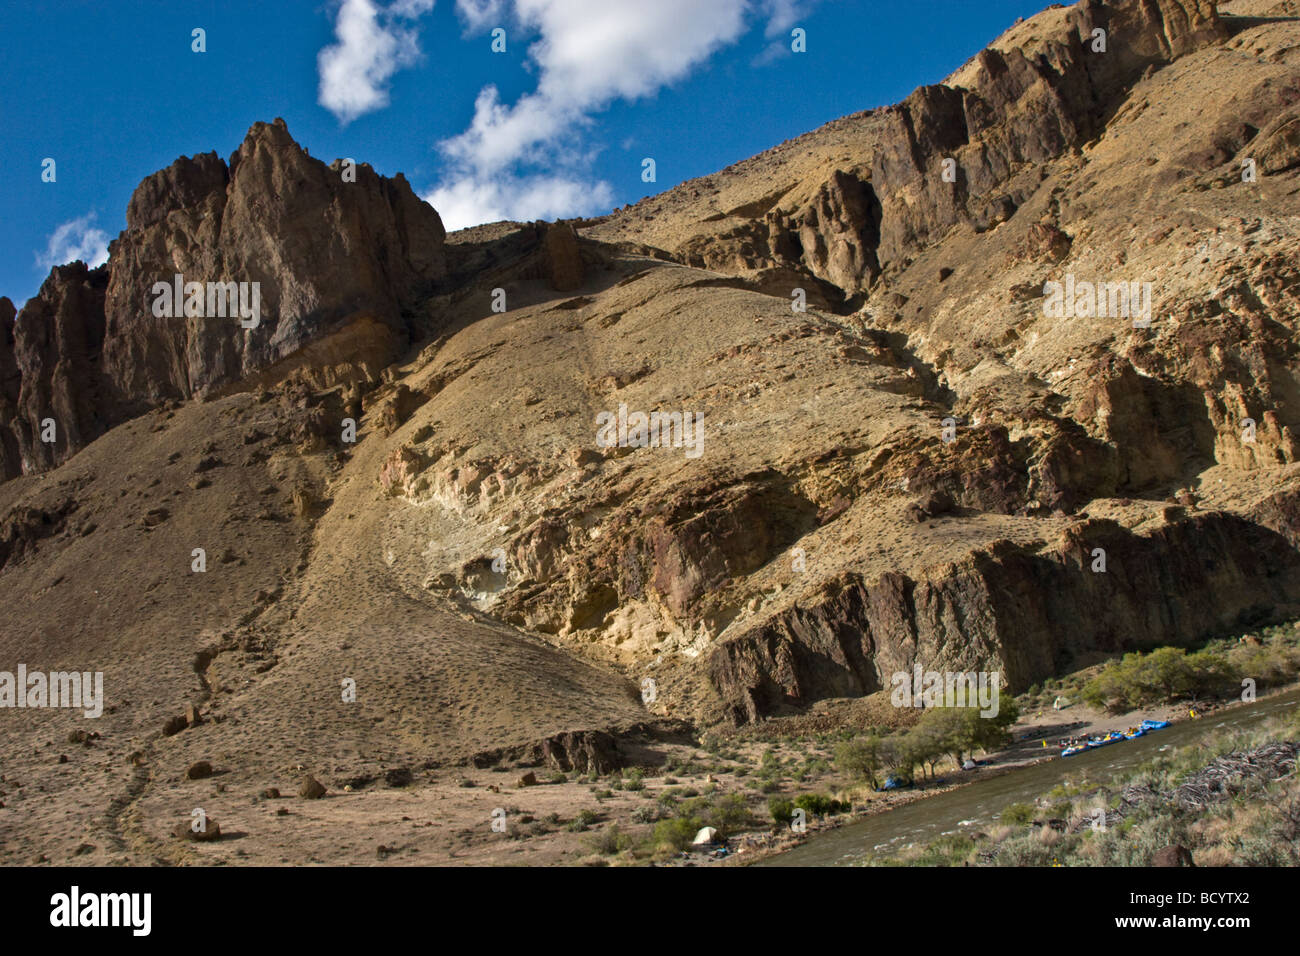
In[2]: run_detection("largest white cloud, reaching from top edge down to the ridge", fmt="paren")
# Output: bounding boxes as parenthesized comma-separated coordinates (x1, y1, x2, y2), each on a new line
(425, 0, 754, 229)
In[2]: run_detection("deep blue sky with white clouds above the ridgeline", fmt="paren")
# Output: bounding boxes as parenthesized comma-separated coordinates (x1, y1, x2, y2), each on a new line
(0, 0, 1047, 307)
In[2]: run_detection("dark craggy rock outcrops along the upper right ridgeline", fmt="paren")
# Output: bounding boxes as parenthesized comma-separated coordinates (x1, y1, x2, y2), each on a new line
(590, 0, 1227, 299)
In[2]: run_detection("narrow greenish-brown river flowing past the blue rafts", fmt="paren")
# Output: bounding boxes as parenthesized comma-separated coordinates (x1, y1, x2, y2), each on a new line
(754, 691, 1300, 866)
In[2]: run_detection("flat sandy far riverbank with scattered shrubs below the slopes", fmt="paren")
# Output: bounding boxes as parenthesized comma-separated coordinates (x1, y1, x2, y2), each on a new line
(159, 627, 1296, 866)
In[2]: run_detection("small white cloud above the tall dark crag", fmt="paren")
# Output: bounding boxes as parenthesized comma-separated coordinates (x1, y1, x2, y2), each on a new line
(316, 0, 434, 124)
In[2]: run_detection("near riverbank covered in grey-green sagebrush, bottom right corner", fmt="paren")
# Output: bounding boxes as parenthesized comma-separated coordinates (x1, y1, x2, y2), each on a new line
(842, 692, 1300, 866)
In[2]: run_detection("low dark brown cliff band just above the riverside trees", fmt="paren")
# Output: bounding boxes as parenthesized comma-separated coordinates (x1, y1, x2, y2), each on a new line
(709, 509, 1300, 723)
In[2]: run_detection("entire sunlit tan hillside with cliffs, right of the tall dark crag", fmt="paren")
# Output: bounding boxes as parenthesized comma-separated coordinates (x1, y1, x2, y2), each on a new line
(312, 0, 1300, 723)
